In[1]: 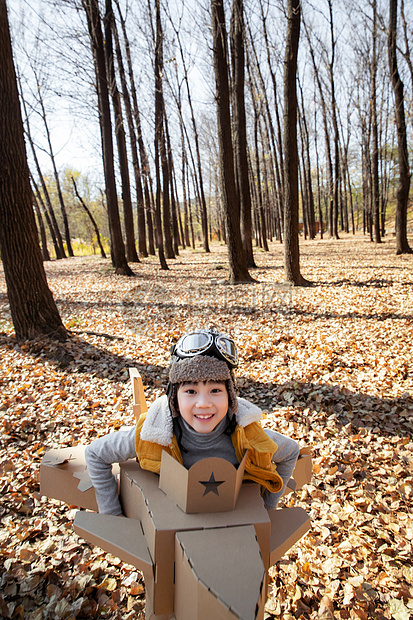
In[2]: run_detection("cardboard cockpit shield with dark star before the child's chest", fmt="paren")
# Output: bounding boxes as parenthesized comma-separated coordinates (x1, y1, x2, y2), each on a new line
(159, 451, 247, 513)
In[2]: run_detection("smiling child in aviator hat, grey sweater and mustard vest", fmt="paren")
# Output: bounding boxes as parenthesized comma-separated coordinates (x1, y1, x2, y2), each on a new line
(85, 329, 299, 515)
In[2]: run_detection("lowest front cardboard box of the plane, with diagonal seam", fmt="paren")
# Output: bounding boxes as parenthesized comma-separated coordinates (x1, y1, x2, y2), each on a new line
(175, 525, 266, 620)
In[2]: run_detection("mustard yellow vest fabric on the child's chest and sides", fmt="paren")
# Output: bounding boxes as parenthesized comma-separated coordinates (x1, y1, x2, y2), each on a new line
(135, 414, 283, 493)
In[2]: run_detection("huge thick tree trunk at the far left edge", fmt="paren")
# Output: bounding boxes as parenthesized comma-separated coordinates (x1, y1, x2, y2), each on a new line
(0, 0, 67, 340)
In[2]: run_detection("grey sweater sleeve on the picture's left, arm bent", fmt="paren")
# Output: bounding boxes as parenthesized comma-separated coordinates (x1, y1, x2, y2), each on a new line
(85, 427, 136, 515)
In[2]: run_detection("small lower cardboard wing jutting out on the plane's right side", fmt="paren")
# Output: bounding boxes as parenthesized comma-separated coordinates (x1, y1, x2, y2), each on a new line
(268, 506, 311, 566)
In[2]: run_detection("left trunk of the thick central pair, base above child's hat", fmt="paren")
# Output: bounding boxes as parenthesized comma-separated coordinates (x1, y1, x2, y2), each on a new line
(211, 0, 252, 284)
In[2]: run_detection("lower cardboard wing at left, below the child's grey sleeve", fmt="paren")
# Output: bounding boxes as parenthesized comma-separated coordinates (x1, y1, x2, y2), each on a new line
(74, 511, 153, 575)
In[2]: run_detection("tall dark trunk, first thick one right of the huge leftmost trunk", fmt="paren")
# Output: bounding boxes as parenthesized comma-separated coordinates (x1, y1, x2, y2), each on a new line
(82, 0, 134, 276)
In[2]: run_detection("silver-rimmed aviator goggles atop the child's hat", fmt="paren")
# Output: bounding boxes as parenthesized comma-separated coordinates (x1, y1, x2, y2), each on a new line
(171, 330, 238, 368)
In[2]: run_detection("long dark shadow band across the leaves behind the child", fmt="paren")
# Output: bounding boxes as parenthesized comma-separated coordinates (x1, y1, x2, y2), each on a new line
(0, 333, 413, 437)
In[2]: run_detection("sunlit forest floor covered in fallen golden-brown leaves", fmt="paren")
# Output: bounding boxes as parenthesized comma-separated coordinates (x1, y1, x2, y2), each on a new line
(0, 236, 413, 620)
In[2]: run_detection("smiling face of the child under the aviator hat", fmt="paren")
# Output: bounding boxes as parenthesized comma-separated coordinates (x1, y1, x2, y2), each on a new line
(177, 381, 228, 433)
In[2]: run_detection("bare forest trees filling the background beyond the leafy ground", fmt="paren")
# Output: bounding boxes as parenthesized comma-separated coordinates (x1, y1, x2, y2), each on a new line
(3, 0, 413, 283)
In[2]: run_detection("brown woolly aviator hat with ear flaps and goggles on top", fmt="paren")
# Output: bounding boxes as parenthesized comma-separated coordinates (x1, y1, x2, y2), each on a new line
(168, 330, 238, 419)
